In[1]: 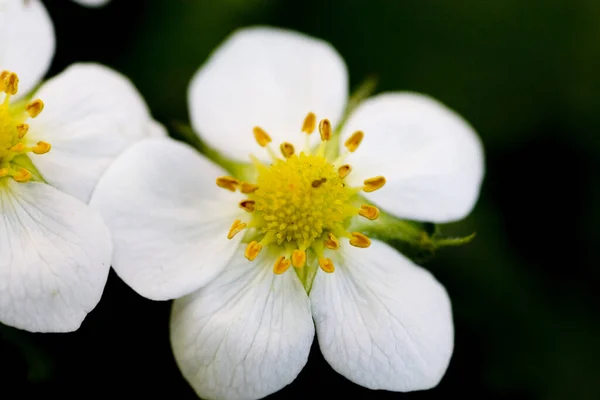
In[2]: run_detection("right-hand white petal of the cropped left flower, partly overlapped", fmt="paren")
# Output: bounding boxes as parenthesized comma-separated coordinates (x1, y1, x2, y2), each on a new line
(27, 64, 155, 202)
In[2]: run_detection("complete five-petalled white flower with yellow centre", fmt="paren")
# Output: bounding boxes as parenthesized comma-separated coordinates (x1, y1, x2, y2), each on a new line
(91, 28, 483, 399)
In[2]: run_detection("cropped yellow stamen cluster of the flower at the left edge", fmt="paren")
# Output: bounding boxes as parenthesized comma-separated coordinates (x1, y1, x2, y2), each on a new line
(0, 71, 51, 182)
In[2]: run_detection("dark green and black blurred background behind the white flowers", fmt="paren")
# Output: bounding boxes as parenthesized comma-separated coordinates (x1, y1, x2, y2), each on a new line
(0, 0, 600, 400)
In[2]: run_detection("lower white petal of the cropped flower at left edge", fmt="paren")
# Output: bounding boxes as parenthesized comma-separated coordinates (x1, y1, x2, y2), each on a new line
(0, 178, 112, 332)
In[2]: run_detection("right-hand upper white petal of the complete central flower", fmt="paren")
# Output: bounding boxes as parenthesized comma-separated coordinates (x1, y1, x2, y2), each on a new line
(342, 92, 484, 222)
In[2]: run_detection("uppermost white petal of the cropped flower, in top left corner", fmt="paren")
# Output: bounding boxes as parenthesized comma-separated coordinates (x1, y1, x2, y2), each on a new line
(0, 0, 56, 96)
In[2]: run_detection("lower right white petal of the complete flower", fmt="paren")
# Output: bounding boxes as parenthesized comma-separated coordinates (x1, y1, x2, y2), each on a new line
(310, 241, 454, 392)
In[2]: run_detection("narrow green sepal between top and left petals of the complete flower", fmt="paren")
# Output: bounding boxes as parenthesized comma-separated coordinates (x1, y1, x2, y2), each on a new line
(172, 121, 256, 181)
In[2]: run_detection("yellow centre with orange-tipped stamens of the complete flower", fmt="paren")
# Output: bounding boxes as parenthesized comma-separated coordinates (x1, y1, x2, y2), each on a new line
(217, 113, 385, 274)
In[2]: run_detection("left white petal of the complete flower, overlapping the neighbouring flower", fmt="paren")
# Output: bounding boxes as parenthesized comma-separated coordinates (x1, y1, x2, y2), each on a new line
(90, 138, 245, 300)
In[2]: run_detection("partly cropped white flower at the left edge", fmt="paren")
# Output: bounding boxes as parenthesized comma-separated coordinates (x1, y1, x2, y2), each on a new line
(0, 1, 160, 332)
